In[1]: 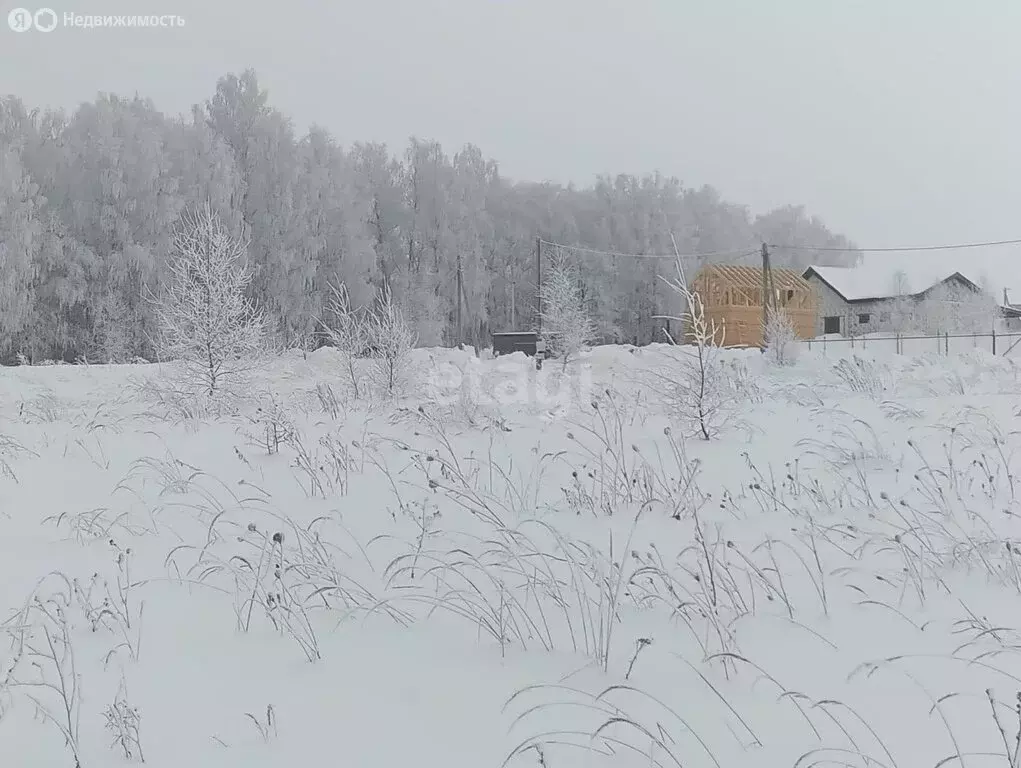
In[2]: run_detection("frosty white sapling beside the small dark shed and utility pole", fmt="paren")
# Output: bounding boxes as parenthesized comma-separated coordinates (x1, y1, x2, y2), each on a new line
(539, 250, 596, 368)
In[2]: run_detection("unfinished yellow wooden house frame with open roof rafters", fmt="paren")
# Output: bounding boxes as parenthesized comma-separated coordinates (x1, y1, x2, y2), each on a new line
(686, 265, 817, 346)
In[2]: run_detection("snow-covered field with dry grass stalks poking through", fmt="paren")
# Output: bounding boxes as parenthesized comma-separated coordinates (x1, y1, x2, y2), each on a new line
(0, 345, 1021, 768)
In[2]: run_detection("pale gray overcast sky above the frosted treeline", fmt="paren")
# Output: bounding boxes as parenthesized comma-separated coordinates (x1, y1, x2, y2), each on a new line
(0, 0, 1021, 252)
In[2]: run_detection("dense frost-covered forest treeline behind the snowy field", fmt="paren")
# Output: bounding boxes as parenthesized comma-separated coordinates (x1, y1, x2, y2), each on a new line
(0, 70, 858, 362)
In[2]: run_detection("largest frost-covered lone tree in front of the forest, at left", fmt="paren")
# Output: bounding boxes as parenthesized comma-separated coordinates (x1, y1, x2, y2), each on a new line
(151, 205, 265, 395)
